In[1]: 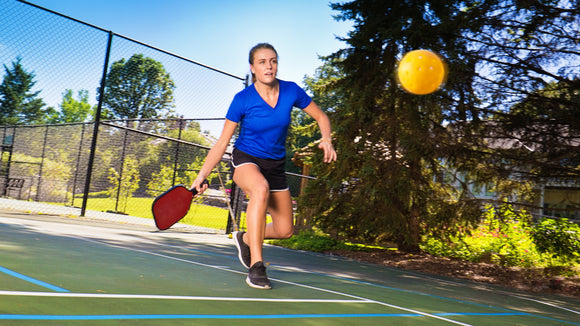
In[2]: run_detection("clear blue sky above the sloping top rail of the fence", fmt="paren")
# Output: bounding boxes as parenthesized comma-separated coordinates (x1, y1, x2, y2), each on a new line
(24, 0, 352, 85)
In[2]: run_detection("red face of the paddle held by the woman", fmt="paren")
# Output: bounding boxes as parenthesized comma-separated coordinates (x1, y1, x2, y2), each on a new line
(152, 185, 195, 230)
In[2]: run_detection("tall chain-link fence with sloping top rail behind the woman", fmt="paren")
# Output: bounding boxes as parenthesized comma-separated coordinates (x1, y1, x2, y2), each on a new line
(0, 0, 318, 232)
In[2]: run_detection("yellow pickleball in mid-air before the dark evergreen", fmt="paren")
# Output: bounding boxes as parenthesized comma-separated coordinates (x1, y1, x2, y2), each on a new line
(397, 50, 446, 95)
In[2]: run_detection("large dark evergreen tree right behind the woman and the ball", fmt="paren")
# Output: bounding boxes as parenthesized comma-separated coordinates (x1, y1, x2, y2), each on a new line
(302, 1, 482, 251)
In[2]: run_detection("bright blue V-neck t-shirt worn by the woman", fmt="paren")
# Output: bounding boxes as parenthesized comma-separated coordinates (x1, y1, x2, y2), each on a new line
(226, 80, 312, 160)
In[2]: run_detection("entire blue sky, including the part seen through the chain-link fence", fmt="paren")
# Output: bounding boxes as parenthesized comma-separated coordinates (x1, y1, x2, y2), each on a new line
(0, 0, 352, 135)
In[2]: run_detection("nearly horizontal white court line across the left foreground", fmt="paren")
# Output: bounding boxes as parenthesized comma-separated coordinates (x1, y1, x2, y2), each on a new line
(0, 291, 364, 303)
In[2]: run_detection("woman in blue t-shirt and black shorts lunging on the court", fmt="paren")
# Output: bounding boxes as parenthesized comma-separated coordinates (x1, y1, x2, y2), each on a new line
(192, 43, 337, 289)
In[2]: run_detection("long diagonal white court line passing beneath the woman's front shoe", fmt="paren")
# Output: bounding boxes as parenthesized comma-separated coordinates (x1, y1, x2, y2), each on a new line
(64, 236, 471, 326)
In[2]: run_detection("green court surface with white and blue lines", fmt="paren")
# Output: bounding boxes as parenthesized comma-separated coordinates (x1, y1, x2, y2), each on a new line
(0, 213, 580, 326)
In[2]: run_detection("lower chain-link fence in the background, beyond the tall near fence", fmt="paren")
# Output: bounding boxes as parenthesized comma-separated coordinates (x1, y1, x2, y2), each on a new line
(0, 119, 236, 230)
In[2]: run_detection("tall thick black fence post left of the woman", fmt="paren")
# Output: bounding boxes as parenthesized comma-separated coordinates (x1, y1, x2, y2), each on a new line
(81, 32, 114, 216)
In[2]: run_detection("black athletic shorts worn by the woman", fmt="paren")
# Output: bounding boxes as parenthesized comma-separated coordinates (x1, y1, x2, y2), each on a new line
(232, 148, 289, 191)
